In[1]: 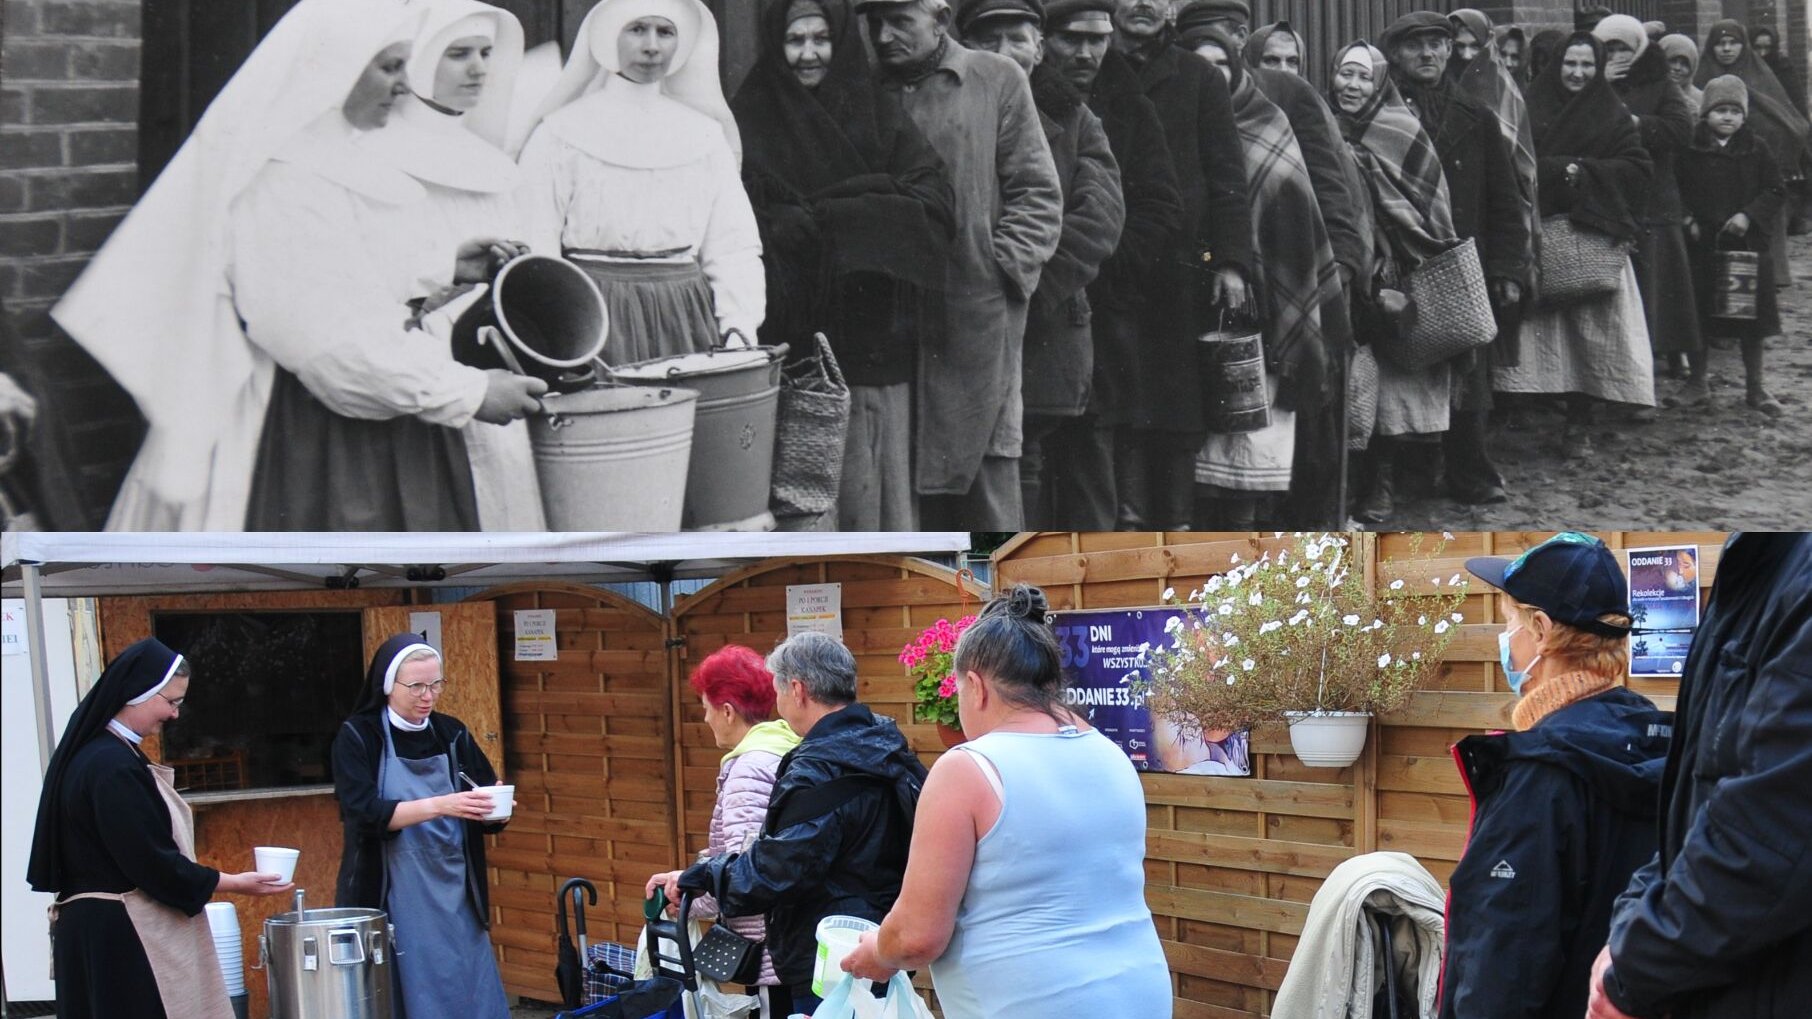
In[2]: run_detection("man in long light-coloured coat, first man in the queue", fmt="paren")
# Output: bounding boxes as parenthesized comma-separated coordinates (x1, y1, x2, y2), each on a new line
(855, 0, 1064, 529)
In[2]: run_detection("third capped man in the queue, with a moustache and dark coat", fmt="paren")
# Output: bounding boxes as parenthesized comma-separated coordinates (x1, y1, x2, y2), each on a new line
(1021, 0, 1183, 531)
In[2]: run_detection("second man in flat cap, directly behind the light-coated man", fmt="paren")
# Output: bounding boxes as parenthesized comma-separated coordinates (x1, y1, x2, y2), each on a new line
(957, 0, 1125, 529)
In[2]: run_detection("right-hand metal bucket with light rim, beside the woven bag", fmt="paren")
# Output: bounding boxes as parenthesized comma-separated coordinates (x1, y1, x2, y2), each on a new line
(611, 346, 786, 531)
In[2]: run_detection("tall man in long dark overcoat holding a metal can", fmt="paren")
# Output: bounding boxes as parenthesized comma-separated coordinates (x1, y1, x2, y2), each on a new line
(1102, 0, 1252, 529)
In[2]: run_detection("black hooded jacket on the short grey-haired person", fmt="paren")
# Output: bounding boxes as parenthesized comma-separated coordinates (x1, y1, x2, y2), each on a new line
(680, 704, 924, 988)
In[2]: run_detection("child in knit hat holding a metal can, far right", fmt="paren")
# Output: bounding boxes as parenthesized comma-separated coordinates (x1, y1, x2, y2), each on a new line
(1669, 74, 1787, 417)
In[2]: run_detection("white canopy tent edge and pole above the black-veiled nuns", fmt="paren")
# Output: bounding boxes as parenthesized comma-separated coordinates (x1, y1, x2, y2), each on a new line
(0, 531, 969, 767)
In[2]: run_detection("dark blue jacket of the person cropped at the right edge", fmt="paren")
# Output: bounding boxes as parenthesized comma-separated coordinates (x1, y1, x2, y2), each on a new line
(1605, 533, 1812, 1019)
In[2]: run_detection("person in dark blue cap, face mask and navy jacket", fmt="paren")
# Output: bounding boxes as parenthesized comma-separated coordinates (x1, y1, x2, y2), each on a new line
(1441, 531, 1672, 1019)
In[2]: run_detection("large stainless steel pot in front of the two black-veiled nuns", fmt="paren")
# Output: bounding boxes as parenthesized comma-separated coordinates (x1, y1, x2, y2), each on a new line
(257, 890, 395, 1019)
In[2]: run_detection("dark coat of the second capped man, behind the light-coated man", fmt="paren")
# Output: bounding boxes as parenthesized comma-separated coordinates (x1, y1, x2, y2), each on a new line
(1026, 67, 1125, 417)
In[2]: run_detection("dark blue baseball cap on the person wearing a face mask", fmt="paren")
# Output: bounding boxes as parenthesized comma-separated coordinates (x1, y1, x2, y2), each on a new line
(1466, 531, 1629, 636)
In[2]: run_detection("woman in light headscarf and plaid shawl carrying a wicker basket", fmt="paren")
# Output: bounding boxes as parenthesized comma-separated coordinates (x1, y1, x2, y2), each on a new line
(1328, 40, 1460, 524)
